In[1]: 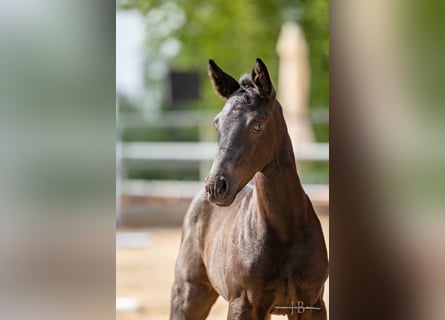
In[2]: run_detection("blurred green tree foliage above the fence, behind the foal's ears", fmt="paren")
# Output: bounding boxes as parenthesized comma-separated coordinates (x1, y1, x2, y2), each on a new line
(117, 0, 329, 109)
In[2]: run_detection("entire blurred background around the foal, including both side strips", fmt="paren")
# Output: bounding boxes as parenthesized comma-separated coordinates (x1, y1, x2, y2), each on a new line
(0, 0, 445, 320)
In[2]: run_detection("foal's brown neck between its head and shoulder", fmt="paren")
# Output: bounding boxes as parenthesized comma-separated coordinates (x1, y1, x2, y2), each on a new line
(255, 108, 308, 242)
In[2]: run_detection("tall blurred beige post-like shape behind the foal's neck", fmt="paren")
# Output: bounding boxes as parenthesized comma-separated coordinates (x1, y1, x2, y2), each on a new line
(277, 22, 314, 146)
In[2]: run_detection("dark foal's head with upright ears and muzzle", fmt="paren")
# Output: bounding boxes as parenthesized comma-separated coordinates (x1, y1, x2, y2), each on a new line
(205, 59, 281, 206)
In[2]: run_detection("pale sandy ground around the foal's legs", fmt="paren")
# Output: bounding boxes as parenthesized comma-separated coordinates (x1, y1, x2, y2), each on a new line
(116, 215, 329, 320)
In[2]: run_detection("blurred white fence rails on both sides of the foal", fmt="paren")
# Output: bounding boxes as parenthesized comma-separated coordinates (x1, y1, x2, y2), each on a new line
(116, 108, 329, 224)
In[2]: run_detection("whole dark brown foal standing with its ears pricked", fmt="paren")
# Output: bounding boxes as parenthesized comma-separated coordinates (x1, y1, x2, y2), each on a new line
(170, 59, 328, 320)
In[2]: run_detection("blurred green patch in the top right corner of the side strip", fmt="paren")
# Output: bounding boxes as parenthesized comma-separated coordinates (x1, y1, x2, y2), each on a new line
(396, 0, 445, 115)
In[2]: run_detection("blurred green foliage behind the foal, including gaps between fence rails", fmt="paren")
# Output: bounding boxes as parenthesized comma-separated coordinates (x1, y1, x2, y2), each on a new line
(117, 0, 329, 182)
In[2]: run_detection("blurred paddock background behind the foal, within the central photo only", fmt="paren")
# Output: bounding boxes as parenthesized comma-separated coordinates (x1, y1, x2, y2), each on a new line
(116, 0, 329, 319)
